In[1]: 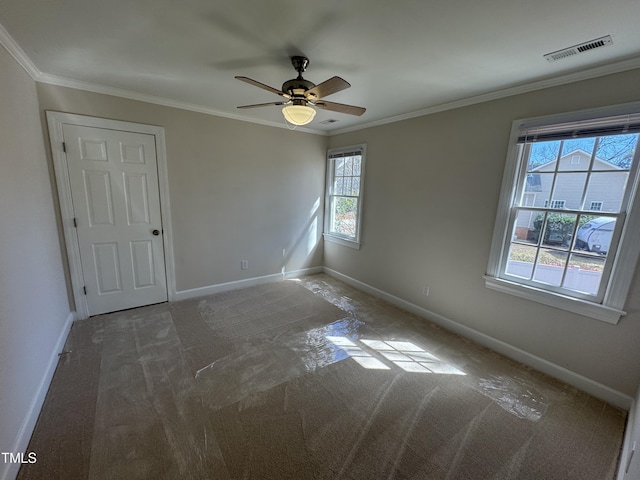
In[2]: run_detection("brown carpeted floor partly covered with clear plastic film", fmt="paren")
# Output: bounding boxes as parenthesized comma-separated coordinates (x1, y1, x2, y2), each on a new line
(18, 275, 626, 480)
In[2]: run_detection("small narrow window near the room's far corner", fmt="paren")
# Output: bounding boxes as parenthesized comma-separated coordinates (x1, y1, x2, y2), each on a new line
(325, 145, 365, 248)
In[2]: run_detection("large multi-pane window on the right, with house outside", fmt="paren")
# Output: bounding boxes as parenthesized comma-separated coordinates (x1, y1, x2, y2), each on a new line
(485, 104, 640, 323)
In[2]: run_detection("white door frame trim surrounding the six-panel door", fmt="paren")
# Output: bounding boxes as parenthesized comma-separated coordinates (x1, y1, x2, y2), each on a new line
(46, 111, 176, 320)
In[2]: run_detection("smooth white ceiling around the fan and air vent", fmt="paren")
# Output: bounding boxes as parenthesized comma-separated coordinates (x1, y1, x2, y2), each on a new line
(0, 0, 640, 132)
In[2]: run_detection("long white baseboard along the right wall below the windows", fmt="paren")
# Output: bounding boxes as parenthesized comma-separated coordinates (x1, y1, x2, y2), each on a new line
(323, 267, 633, 410)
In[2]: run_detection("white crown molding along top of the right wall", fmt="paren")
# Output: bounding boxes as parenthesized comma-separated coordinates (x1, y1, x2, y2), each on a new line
(329, 57, 640, 136)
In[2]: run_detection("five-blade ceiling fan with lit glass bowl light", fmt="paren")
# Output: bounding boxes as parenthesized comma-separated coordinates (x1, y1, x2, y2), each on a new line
(235, 56, 366, 125)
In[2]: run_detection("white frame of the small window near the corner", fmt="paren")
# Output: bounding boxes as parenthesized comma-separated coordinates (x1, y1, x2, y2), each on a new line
(323, 144, 367, 249)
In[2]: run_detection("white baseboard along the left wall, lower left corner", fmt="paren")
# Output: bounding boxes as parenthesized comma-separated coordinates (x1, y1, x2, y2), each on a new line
(0, 312, 75, 480)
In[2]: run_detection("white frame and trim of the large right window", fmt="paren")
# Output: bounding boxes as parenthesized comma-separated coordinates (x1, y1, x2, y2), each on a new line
(484, 102, 640, 324)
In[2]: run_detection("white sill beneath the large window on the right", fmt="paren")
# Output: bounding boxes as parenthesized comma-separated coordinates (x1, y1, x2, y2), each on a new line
(484, 275, 626, 325)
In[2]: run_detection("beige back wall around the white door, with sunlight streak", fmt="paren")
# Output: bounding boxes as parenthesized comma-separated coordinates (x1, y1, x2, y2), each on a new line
(37, 84, 327, 291)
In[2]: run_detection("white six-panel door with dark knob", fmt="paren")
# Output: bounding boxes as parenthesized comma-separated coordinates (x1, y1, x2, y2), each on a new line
(62, 124, 167, 315)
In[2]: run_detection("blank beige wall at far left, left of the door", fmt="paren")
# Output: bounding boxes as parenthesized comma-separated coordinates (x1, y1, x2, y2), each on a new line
(0, 46, 70, 468)
